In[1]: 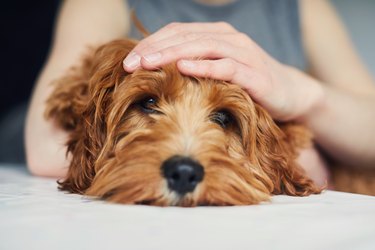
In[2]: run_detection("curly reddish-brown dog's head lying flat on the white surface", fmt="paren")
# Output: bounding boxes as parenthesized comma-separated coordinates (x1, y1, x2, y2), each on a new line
(47, 40, 319, 206)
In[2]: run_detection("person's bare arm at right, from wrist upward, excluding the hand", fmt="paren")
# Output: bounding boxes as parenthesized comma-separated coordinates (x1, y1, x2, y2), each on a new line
(301, 0, 375, 167)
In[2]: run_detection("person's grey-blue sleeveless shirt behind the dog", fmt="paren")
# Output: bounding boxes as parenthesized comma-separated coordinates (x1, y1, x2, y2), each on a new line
(128, 0, 306, 70)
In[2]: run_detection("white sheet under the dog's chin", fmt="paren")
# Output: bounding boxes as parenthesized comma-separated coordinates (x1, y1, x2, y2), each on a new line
(0, 166, 375, 250)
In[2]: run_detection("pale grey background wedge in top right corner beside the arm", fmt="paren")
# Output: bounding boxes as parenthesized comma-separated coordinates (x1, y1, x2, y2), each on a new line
(334, 0, 375, 76)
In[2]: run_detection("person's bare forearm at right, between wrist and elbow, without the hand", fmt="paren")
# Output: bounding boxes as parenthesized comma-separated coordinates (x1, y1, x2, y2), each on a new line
(295, 68, 375, 167)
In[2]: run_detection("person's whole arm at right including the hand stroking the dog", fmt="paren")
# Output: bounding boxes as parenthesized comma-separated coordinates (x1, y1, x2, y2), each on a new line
(124, 0, 375, 166)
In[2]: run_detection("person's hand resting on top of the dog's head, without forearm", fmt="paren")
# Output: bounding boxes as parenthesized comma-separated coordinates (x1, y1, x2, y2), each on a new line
(124, 22, 322, 121)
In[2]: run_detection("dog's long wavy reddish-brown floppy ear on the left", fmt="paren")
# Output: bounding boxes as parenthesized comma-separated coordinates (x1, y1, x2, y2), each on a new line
(45, 40, 136, 193)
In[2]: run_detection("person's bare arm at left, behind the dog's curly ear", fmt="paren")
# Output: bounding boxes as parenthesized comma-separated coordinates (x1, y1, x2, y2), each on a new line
(25, 0, 129, 177)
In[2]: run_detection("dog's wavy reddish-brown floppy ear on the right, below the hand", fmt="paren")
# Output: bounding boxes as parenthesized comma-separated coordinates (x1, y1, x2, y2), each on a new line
(251, 104, 321, 196)
